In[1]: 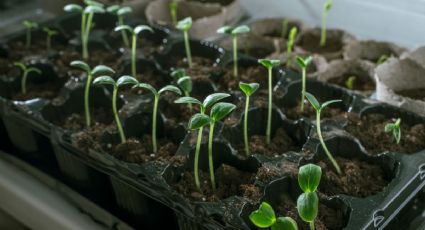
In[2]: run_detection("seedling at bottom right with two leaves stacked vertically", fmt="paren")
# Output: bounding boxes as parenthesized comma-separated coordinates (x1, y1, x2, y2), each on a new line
(297, 164, 322, 230)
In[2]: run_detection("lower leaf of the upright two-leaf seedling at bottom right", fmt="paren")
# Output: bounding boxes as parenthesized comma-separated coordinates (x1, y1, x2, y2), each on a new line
(297, 192, 319, 222)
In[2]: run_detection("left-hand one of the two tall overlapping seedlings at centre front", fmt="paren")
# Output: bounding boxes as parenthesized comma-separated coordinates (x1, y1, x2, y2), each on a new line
(175, 93, 230, 190)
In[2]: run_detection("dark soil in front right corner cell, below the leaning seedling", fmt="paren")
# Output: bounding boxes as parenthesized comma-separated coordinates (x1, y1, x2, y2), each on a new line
(317, 157, 390, 197)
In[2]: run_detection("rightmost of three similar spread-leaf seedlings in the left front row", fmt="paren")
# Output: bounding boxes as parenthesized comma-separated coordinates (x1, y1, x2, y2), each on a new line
(133, 83, 181, 153)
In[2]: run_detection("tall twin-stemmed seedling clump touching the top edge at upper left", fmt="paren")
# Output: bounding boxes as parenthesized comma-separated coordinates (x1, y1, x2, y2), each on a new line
(64, 0, 105, 60)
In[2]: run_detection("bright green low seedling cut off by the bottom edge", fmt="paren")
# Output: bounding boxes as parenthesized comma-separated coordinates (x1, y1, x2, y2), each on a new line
(249, 201, 298, 230)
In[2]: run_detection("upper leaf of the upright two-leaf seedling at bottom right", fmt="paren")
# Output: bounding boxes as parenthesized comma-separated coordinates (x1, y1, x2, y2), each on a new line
(298, 164, 322, 192)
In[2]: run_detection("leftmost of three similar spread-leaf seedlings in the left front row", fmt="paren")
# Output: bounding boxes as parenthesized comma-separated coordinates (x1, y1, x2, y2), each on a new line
(70, 61, 115, 128)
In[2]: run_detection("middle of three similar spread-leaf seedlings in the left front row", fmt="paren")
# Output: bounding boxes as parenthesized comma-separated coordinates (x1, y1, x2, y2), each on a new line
(93, 75, 138, 143)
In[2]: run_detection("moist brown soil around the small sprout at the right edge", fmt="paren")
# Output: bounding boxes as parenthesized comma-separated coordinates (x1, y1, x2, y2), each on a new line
(345, 114, 425, 155)
